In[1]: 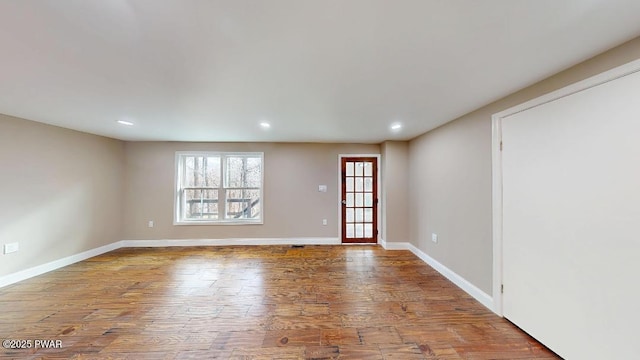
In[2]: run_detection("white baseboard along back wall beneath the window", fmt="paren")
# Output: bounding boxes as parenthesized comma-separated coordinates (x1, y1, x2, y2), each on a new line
(121, 238, 340, 247)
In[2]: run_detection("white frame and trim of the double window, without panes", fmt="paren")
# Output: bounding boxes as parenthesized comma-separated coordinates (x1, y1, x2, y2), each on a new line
(173, 151, 264, 225)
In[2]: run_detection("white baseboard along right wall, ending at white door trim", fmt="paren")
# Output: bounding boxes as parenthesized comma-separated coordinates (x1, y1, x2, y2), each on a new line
(384, 242, 495, 312)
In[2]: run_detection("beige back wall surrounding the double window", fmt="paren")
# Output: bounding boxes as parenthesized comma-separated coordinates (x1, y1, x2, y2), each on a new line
(124, 142, 380, 240)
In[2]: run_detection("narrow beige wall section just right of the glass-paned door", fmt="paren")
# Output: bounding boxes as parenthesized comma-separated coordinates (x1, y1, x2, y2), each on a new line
(380, 141, 410, 242)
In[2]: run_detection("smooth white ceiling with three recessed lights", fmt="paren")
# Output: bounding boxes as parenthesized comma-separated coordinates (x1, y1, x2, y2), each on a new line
(0, 0, 640, 143)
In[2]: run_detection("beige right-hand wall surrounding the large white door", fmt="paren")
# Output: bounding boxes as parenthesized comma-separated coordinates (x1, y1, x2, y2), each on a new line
(409, 38, 640, 294)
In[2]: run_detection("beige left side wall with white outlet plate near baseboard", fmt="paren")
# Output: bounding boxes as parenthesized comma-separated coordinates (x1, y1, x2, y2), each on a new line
(0, 115, 124, 276)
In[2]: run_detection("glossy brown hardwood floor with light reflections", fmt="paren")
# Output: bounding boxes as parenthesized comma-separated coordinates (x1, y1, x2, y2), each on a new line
(0, 246, 557, 360)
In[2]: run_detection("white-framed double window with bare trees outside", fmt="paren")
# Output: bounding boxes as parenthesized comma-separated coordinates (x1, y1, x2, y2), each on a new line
(175, 152, 264, 224)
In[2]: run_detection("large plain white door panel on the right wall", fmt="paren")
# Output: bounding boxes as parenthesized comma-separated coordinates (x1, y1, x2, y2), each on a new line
(502, 66, 640, 359)
